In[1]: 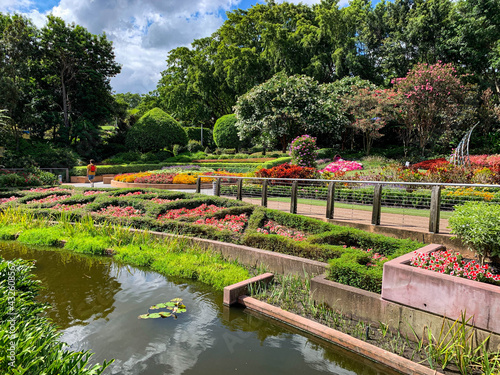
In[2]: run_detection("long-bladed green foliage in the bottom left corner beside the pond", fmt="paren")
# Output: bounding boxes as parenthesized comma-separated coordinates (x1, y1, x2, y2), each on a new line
(0, 258, 113, 375)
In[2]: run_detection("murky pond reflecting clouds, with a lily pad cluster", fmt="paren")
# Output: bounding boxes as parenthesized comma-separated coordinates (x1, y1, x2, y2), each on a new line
(0, 242, 393, 375)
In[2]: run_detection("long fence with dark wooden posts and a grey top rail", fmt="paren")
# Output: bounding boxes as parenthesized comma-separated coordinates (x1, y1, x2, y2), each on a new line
(197, 176, 500, 233)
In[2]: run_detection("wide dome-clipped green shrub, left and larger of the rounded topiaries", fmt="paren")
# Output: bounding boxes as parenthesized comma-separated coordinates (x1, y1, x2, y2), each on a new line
(125, 108, 188, 152)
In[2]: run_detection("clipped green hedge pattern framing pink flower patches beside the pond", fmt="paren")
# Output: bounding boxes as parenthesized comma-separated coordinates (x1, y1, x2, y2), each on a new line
(0, 189, 423, 293)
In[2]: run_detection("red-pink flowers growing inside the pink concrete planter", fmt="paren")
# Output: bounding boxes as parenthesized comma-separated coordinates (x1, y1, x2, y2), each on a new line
(410, 251, 500, 285)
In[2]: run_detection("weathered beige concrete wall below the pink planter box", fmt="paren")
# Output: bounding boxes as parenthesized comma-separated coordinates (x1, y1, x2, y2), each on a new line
(311, 275, 500, 351)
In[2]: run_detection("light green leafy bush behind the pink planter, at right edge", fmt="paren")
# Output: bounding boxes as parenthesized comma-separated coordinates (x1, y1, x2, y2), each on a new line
(449, 202, 500, 263)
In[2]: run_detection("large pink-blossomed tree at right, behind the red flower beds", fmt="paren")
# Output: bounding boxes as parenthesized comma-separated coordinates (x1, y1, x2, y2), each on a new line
(391, 61, 466, 155)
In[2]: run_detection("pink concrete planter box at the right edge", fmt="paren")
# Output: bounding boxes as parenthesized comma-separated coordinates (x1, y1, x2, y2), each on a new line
(382, 245, 500, 334)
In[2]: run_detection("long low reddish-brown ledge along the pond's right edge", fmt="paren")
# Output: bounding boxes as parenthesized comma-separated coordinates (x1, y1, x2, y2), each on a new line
(238, 296, 441, 375)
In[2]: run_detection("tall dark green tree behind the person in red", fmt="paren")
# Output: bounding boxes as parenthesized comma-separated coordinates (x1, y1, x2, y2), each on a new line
(40, 15, 121, 143)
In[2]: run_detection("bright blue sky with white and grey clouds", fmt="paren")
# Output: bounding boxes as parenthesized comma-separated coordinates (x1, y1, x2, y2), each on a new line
(0, 0, 328, 94)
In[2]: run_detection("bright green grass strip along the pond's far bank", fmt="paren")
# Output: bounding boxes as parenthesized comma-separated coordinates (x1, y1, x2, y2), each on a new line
(0, 210, 250, 290)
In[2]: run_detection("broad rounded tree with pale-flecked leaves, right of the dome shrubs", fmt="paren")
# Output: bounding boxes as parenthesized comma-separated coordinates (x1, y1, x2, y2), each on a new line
(234, 73, 345, 152)
